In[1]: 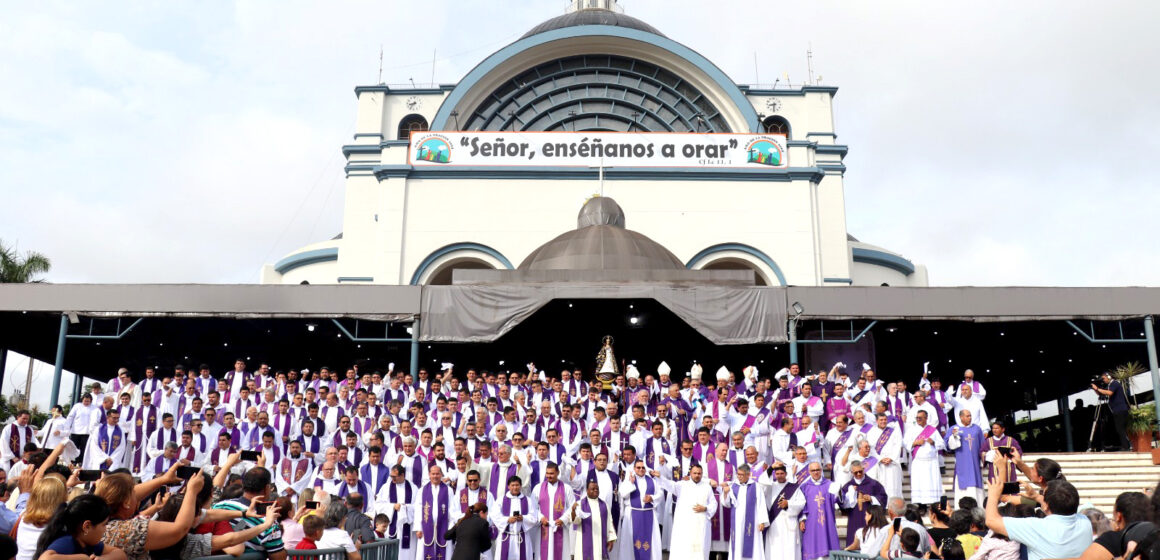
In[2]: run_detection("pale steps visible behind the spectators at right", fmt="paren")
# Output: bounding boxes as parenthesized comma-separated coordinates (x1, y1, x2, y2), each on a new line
(838, 452, 1160, 543)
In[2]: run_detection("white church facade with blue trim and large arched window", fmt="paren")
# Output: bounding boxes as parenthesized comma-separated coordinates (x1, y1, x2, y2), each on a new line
(261, 0, 927, 286)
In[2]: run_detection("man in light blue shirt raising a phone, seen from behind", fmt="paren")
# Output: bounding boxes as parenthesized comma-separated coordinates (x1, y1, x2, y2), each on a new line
(986, 480, 1092, 560)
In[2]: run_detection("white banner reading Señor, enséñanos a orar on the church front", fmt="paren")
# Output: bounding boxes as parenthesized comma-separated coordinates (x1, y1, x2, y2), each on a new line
(407, 132, 789, 169)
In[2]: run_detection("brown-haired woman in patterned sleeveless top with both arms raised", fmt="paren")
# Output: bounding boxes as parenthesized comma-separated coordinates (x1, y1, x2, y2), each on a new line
(94, 461, 205, 560)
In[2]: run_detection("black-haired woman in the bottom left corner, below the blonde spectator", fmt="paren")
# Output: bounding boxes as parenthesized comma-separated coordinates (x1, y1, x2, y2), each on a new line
(34, 494, 125, 560)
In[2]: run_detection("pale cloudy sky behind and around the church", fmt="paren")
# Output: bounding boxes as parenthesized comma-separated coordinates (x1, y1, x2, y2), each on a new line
(0, 0, 1160, 285)
